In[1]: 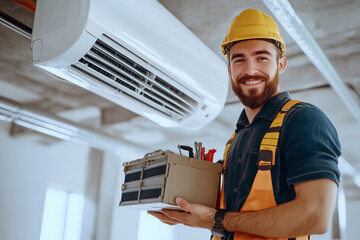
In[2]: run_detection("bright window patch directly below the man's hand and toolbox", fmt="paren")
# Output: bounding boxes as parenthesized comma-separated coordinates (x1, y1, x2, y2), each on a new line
(138, 211, 174, 240)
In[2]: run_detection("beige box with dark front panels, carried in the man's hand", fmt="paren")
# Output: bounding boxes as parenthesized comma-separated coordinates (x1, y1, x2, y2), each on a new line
(119, 150, 222, 211)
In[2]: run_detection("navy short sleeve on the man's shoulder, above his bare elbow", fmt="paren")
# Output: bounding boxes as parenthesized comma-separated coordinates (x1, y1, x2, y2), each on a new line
(280, 103, 341, 186)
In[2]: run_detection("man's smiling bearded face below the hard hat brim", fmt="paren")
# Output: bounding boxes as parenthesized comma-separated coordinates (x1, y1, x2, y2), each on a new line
(228, 39, 286, 109)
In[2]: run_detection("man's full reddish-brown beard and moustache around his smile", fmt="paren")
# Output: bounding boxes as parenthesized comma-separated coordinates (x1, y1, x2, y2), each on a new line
(231, 71, 279, 109)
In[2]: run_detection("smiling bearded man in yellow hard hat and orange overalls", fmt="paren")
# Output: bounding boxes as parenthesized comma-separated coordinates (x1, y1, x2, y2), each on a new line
(150, 9, 340, 240)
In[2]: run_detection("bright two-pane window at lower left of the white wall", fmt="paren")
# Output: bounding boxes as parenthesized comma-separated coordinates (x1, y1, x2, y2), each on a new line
(40, 188, 84, 240)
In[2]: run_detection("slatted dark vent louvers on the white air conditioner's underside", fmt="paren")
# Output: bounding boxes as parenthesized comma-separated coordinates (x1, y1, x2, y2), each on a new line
(70, 36, 199, 121)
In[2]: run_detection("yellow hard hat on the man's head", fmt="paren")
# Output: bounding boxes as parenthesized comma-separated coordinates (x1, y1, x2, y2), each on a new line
(221, 9, 286, 56)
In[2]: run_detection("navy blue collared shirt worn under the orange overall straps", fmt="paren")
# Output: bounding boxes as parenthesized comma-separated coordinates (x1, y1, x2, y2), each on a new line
(224, 92, 340, 218)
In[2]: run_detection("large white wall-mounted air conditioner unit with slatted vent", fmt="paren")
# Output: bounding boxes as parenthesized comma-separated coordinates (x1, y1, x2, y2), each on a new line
(32, 0, 229, 128)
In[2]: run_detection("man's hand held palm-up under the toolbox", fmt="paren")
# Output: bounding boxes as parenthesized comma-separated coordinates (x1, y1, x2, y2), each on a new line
(148, 197, 216, 229)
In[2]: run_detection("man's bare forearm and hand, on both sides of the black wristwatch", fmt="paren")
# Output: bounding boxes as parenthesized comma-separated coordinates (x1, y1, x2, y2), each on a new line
(151, 179, 337, 238)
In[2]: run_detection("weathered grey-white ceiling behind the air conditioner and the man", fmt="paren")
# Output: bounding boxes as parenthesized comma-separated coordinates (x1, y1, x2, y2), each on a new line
(0, 0, 360, 199)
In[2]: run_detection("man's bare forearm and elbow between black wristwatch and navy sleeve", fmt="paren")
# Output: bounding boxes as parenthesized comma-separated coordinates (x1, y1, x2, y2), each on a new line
(223, 179, 337, 238)
